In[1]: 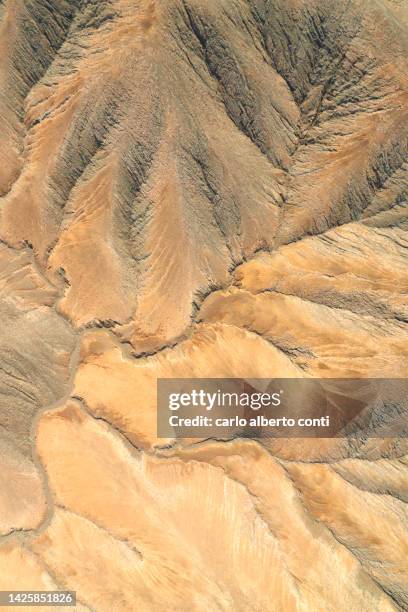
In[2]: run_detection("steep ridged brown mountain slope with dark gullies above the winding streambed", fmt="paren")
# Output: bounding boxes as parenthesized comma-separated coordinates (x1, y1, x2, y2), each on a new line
(1, 0, 408, 350)
